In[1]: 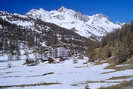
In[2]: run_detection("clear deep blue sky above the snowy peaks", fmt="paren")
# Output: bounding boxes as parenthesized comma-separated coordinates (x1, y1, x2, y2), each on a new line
(0, 0, 133, 22)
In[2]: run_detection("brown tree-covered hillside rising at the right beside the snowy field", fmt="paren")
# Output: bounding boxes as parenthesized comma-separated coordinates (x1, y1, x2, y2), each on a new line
(89, 23, 133, 64)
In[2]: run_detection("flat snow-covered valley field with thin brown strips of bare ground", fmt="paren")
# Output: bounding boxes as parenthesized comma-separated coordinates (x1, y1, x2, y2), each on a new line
(0, 58, 133, 89)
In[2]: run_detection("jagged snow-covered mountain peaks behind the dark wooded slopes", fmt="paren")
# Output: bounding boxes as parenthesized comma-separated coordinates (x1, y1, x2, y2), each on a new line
(26, 7, 121, 38)
